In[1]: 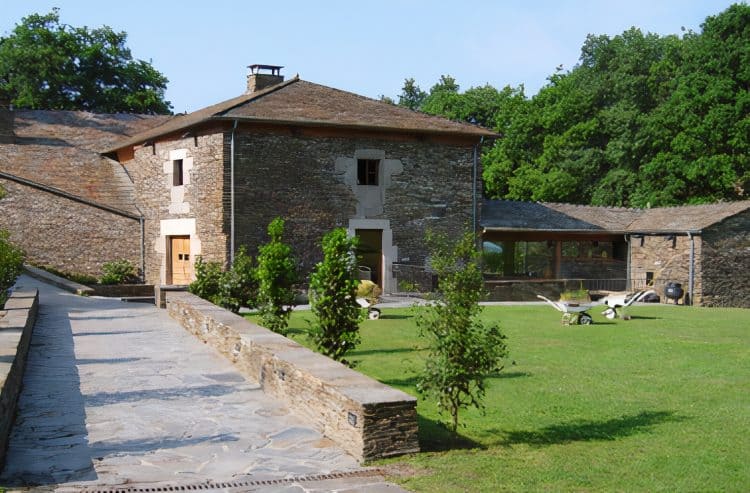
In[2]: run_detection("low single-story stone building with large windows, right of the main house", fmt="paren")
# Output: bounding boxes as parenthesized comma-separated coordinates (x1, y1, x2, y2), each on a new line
(481, 200, 750, 308)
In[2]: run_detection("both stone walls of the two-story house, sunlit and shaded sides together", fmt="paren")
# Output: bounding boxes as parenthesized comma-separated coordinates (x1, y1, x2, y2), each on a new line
(123, 126, 473, 290)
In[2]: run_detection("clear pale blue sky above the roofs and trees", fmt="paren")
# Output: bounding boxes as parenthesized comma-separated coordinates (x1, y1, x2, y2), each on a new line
(0, 0, 735, 112)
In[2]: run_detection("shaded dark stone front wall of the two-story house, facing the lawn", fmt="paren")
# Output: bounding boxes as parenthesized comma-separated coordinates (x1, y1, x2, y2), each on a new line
(235, 131, 473, 272)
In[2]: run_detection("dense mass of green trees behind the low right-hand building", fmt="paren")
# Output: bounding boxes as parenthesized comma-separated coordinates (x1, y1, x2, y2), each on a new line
(399, 4, 750, 207)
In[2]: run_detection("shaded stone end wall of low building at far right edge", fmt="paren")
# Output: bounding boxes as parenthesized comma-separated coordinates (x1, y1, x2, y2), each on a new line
(702, 211, 750, 308)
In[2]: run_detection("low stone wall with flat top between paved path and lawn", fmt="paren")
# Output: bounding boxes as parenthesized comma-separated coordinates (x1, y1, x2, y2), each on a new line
(166, 291, 419, 460)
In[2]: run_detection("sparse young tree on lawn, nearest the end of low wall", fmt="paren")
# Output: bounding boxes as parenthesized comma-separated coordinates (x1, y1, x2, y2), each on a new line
(417, 229, 507, 431)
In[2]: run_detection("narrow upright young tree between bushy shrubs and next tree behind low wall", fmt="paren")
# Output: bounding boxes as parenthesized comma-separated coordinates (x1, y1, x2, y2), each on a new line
(255, 217, 298, 334)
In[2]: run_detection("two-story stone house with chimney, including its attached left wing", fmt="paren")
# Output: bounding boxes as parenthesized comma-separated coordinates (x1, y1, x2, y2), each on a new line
(0, 65, 496, 292)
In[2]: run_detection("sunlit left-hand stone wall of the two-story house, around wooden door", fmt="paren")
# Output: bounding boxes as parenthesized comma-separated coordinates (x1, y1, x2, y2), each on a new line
(123, 129, 229, 284)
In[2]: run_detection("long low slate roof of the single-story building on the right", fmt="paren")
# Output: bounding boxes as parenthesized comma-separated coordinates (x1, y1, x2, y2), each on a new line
(480, 200, 750, 234)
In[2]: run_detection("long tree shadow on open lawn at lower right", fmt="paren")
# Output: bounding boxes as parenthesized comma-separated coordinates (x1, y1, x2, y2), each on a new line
(498, 411, 687, 445)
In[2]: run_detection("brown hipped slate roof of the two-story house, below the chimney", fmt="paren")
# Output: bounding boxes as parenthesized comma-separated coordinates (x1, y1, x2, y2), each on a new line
(104, 77, 497, 152)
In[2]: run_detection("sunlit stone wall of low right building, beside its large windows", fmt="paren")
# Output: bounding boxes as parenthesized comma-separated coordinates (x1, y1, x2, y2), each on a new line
(630, 236, 704, 305)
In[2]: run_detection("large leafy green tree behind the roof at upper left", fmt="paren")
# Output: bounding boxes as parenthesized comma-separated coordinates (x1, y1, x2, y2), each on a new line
(0, 8, 172, 114)
